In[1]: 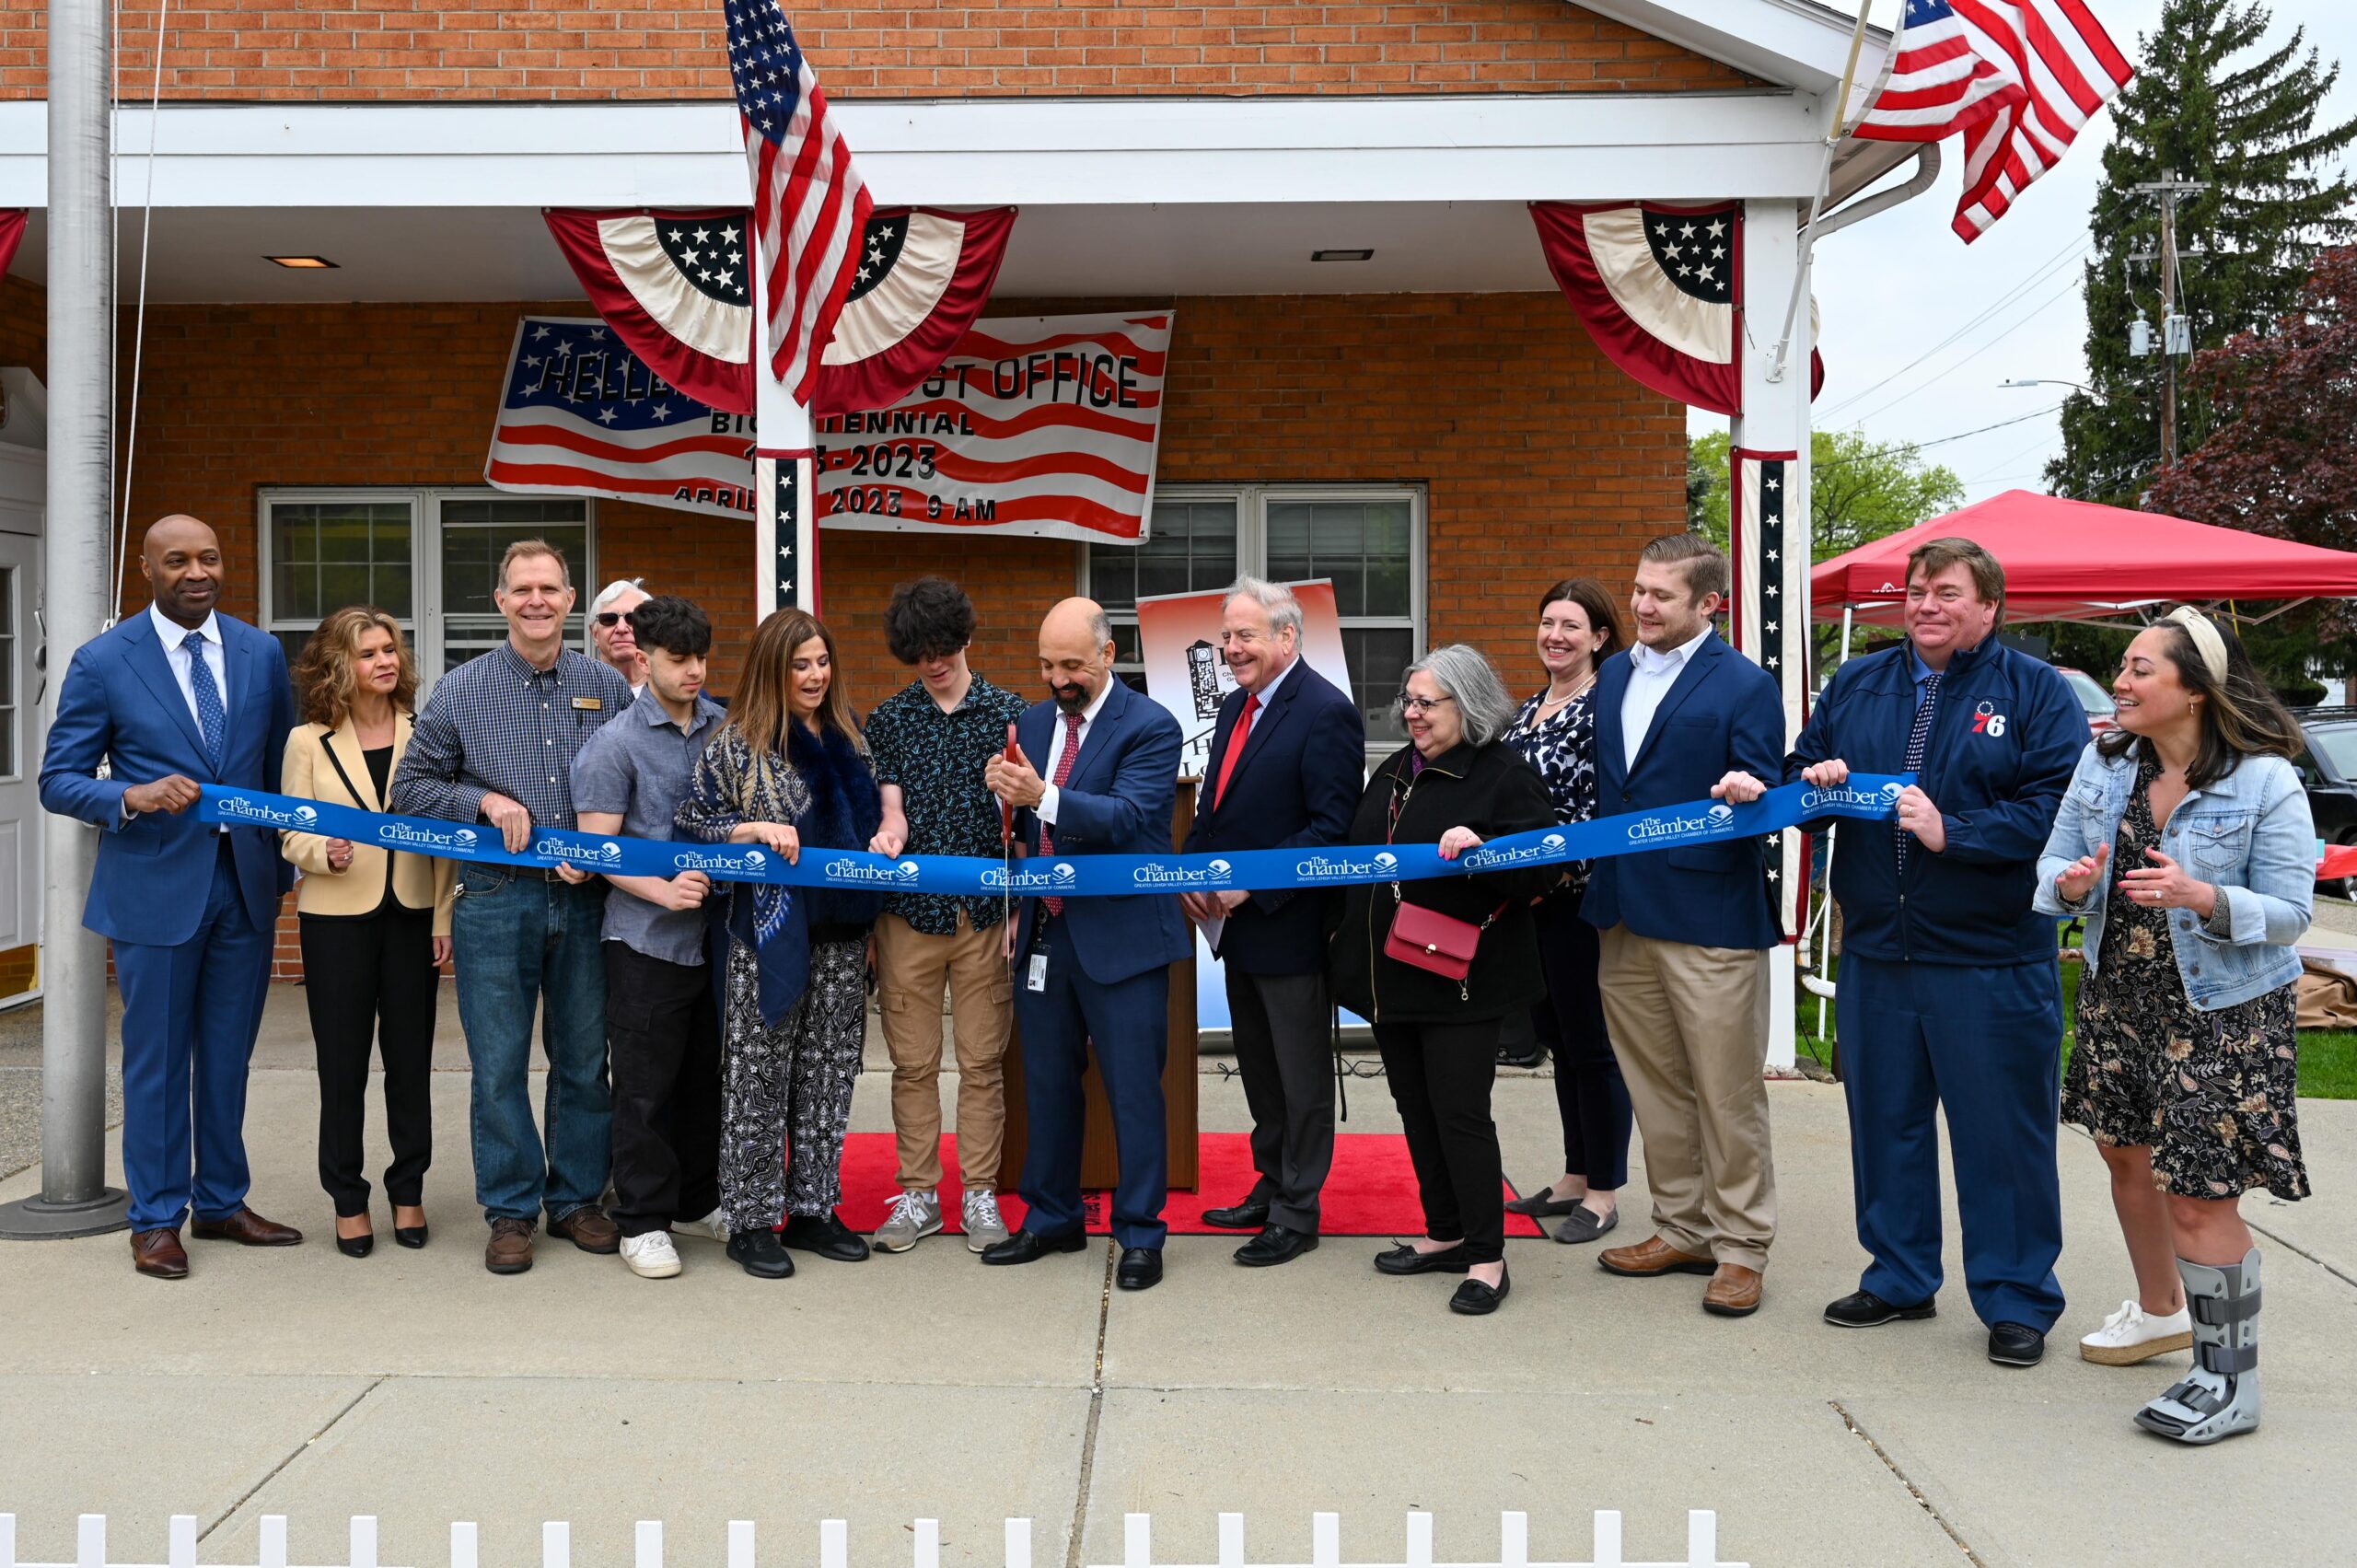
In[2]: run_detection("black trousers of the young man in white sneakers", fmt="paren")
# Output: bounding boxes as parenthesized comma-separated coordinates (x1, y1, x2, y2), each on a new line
(606, 941, 721, 1236)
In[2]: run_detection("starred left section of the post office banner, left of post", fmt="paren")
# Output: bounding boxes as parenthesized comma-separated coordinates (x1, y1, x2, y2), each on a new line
(483, 316, 754, 518)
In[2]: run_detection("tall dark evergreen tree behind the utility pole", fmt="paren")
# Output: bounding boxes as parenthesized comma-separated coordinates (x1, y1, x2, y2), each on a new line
(2046, 0, 2357, 507)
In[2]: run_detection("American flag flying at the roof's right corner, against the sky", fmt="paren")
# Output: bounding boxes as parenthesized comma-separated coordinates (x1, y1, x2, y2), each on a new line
(1855, 0, 2129, 243)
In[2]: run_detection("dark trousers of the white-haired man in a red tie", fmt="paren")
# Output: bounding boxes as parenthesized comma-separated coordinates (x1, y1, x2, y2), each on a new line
(1225, 964, 1334, 1236)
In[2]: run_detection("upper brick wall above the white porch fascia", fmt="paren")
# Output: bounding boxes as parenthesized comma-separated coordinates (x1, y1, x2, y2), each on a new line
(0, 0, 1744, 99)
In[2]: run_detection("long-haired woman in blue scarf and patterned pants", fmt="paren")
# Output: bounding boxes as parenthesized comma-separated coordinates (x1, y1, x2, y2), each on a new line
(674, 610, 884, 1281)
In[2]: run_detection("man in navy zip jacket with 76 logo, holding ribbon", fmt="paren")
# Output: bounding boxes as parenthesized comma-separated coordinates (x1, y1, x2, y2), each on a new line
(1727, 538, 2088, 1367)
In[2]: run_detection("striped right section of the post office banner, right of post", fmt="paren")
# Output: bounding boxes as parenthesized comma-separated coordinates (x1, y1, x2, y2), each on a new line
(818, 311, 1171, 545)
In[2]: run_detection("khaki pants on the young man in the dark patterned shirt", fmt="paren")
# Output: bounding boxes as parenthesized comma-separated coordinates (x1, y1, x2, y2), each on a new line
(877, 912, 1014, 1193)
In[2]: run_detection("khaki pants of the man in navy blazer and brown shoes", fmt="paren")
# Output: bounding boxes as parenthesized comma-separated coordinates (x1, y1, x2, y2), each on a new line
(1596, 924, 1775, 1269)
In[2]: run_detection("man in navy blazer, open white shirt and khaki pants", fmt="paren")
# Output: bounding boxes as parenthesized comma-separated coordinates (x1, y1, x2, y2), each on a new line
(1582, 533, 1784, 1318)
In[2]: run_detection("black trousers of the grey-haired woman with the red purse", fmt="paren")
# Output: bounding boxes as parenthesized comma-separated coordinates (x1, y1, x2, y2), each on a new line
(1374, 1018, 1506, 1264)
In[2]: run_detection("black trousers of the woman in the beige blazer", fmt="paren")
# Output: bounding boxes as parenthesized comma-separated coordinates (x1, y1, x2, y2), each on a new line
(299, 903, 441, 1216)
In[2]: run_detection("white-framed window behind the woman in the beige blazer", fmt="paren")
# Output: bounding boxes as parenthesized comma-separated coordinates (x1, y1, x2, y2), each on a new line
(260, 488, 597, 686)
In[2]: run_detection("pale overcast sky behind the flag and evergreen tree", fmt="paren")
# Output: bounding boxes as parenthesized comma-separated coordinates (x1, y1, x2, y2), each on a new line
(1692, 0, 2357, 500)
